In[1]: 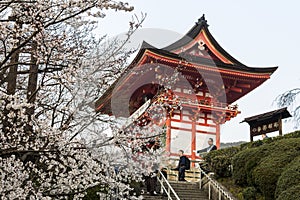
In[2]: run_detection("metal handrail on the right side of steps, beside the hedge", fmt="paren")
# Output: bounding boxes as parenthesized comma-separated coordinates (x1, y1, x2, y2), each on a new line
(199, 166, 234, 200)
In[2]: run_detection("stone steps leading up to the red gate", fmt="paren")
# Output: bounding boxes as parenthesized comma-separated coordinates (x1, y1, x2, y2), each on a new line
(143, 181, 208, 200)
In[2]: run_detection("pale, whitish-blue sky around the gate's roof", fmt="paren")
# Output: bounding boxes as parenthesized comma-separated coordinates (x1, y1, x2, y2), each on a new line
(98, 0, 300, 142)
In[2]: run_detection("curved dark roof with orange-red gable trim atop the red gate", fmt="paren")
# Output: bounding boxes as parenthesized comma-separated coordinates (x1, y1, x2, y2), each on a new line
(95, 15, 277, 113)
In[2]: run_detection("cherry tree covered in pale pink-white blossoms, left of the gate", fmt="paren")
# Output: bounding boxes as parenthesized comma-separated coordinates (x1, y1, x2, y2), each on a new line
(0, 0, 161, 199)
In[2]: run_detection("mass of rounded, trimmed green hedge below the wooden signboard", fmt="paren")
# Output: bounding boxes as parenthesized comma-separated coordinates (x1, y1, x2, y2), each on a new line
(206, 131, 300, 200)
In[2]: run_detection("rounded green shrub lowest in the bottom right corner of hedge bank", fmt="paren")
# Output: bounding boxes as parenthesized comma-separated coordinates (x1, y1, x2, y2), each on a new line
(275, 156, 300, 197)
